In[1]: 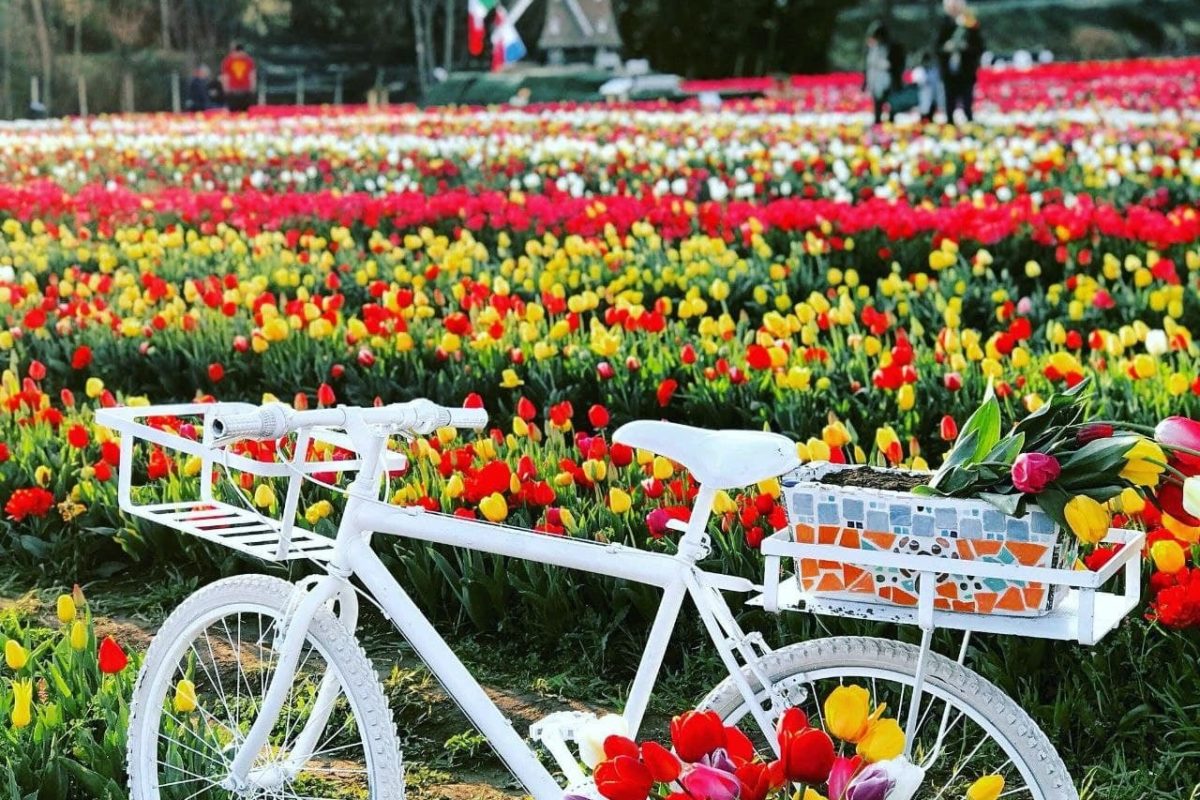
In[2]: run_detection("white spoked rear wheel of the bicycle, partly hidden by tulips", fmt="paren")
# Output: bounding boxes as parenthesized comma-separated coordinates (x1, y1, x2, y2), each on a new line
(700, 636, 1079, 800)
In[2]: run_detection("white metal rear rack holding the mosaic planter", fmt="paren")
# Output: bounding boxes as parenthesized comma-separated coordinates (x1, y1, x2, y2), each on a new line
(750, 528, 1146, 644)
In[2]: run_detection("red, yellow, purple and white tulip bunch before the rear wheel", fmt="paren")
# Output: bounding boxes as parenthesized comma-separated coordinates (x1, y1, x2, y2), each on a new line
(566, 685, 1004, 800)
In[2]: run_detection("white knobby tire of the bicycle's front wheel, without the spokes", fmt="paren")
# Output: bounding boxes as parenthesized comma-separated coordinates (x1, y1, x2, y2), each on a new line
(126, 575, 404, 800)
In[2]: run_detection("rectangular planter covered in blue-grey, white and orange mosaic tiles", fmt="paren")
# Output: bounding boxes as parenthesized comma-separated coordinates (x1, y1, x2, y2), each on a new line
(782, 464, 1075, 616)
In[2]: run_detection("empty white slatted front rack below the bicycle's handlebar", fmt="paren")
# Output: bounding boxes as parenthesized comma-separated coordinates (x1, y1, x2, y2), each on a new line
(96, 403, 406, 561)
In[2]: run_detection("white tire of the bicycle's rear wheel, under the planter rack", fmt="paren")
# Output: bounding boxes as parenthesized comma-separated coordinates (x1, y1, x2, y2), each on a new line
(698, 636, 1079, 800)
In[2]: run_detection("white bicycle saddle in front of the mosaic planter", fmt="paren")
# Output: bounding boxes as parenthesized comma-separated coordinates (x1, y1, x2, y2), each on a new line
(612, 420, 800, 489)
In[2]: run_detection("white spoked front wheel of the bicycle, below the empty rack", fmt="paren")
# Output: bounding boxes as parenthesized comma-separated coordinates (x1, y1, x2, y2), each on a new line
(128, 575, 404, 800)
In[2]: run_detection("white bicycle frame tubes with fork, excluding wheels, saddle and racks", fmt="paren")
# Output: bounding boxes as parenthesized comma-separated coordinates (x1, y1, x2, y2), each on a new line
(227, 419, 780, 800)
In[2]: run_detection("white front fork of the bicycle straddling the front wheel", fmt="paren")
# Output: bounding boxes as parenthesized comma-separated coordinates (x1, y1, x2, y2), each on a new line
(221, 573, 358, 792)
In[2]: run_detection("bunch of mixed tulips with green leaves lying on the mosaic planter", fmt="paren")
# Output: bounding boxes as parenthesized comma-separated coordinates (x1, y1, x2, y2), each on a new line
(913, 379, 1200, 545)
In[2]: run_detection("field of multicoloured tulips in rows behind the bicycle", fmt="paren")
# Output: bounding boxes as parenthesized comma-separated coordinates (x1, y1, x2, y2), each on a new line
(0, 54, 1200, 800)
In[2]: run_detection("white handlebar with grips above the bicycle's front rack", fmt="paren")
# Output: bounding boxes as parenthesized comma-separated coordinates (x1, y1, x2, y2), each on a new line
(212, 399, 487, 443)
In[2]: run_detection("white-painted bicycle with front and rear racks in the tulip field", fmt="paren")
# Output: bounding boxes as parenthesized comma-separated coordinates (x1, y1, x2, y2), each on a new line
(98, 401, 1141, 800)
